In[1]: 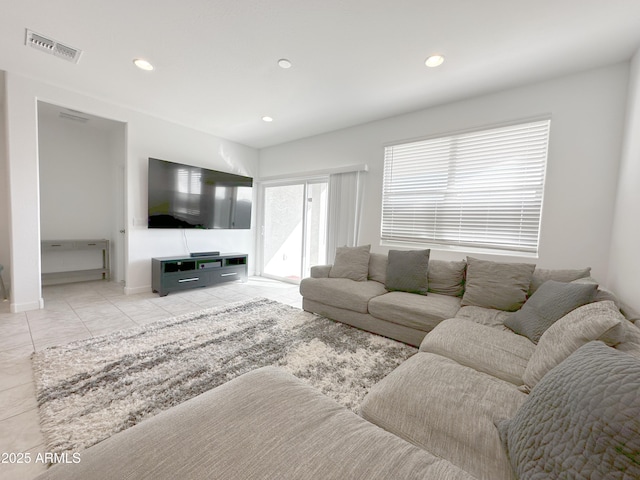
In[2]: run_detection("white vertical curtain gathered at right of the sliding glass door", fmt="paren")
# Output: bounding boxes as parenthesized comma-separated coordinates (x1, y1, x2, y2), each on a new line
(327, 171, 364, 263)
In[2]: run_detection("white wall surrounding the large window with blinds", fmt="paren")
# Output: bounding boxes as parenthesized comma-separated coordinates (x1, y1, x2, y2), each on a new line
(260, 63, 628, 279)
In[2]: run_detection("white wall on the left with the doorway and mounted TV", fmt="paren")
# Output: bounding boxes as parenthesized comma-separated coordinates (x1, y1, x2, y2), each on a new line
(6, 72, 258, 311)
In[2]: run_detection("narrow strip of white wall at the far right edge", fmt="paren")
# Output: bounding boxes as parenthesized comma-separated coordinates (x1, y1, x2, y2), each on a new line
(608, 50, 640, 311)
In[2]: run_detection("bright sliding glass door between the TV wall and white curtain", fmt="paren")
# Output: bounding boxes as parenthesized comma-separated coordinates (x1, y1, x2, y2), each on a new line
(262, 180, 329, 283)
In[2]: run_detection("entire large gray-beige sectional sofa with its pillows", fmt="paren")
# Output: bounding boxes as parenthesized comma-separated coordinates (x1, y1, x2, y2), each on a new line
(39, 249, 640, 480)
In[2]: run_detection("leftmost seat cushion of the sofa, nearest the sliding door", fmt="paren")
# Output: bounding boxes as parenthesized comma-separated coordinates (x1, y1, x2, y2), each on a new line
(300, 278, 384, 313)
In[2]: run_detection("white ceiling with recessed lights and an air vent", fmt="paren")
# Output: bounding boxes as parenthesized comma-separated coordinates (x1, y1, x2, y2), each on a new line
(0, 0, 640, 148)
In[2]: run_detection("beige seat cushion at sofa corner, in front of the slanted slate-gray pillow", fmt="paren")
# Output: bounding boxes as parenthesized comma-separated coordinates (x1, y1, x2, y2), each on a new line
(420, 318, 535, 385)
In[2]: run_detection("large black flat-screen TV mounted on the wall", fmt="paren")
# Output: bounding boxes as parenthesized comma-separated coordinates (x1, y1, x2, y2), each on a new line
(149, 158, 253, 229)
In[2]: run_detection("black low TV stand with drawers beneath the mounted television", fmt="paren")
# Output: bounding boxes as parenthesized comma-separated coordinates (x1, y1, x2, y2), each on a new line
(151, 253, 248, 297)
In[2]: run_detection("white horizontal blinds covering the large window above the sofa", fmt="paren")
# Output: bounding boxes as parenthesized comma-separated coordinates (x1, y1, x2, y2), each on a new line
(381, 120, 550, 253)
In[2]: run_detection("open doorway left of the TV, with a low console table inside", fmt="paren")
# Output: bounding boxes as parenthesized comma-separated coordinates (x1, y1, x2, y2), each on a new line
(38, 101, 127, 283)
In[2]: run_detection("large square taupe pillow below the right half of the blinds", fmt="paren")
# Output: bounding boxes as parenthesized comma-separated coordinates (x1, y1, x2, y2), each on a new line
(462, 257, 535, 312)
